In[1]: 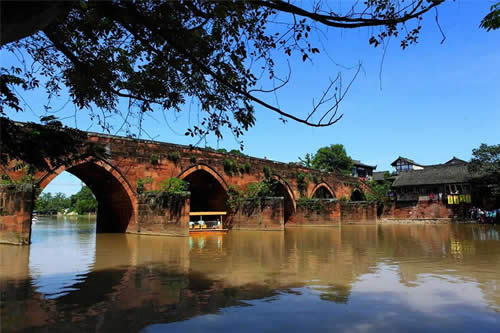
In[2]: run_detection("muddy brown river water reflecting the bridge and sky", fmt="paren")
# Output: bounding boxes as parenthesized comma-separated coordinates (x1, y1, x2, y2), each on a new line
(0, 218, 500, 332)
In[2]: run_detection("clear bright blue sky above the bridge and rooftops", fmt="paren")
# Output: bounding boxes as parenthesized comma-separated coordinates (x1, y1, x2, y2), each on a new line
(0, 0, 500, 194)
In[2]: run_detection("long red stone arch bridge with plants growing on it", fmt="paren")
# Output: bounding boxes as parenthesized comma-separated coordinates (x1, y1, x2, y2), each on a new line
(0, 133, 376, 244)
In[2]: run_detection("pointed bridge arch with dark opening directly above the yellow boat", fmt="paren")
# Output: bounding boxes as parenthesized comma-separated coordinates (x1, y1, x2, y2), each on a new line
(178, 164, 228, 212)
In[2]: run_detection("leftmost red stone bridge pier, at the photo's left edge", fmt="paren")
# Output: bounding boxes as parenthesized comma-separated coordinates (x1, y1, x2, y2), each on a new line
(0, 185, 33, 245)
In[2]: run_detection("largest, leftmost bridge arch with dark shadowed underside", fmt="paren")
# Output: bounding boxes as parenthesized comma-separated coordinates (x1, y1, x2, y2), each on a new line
(38, 159, 136, 232)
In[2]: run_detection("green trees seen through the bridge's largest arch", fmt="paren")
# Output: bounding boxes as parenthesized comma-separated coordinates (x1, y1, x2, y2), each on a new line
(35, 186, 97, 214)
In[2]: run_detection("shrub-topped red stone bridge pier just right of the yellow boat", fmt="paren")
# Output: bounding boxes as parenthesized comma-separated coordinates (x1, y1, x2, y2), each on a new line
(226, 197, 285, 230)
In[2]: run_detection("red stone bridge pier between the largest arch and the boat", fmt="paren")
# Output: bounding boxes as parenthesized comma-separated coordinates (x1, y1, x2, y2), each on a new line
(135, 195, 189, 236)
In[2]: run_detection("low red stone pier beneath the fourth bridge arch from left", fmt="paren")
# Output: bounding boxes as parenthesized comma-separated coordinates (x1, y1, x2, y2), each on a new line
(286, 199, 341, 227)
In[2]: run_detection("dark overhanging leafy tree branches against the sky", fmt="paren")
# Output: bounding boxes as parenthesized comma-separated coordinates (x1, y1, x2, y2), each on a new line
(0, 0, 444, 158)
